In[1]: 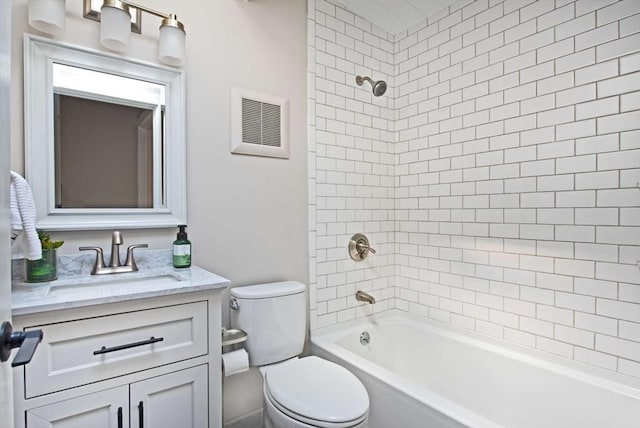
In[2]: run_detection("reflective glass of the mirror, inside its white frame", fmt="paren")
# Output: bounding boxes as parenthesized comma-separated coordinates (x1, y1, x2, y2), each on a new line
(53, 63, 165, 209)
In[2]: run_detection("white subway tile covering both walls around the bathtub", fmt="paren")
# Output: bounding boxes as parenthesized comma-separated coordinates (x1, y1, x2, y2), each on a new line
(308, 0, 640, 377)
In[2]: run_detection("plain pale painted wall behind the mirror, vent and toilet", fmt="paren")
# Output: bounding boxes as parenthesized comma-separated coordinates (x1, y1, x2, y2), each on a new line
(11, 0, 308, 420)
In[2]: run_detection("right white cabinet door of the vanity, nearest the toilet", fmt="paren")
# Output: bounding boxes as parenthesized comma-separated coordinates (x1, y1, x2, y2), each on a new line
(130, 364, 209, 428)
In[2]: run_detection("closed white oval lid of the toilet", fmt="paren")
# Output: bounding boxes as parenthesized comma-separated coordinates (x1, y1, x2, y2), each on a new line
(265, 356, 369, 426)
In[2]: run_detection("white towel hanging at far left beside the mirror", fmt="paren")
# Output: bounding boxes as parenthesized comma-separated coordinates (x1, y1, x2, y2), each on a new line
(9, 171, 42, 260)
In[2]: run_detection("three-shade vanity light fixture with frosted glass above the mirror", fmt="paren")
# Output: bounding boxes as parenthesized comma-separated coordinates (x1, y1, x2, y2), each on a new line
(29, 0, 186, 66)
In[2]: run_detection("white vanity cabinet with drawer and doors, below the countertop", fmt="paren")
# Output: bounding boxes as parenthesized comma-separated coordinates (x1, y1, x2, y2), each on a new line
(13, 289, 222, 428)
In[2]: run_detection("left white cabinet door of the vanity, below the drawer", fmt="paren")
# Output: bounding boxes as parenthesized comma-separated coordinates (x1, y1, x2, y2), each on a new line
(27, 385, 129, 428)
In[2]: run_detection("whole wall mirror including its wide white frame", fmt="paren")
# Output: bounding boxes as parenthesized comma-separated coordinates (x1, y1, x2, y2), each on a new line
(25, 35, 186, 230)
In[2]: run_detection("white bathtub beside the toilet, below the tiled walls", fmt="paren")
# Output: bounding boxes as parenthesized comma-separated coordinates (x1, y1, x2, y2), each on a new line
(311, 311, 640, 428)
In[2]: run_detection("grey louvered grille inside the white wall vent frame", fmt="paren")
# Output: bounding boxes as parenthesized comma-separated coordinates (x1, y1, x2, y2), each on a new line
(242, 98, 282, 147)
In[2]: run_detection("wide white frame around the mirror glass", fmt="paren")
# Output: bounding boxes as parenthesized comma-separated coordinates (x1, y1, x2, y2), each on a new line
(24, 34, 187, 230)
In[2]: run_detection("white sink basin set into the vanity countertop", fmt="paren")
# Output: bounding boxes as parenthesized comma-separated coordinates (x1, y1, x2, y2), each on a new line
(49, 273, 183, 295)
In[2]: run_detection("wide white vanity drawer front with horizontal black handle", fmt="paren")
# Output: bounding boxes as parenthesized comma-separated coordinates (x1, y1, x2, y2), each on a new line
(25, 302, 208, 398)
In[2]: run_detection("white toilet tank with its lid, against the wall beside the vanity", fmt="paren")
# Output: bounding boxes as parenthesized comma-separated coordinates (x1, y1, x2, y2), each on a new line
(230, 281, 307, 366)
